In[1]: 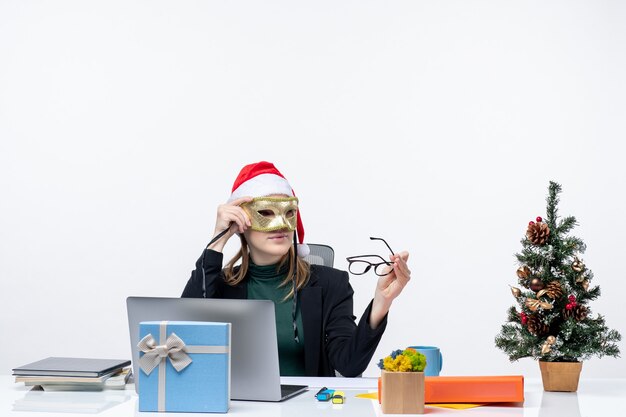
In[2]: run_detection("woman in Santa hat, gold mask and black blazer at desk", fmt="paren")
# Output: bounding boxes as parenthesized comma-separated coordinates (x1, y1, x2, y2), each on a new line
(182, 161, 410, 376)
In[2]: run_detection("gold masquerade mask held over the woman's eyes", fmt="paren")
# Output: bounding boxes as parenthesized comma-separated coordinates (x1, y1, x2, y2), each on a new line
(241, 197, 298, 232)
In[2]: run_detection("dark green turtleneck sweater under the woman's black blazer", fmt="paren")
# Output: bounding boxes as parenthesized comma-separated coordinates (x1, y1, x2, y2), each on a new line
(248, 261, 305, 376)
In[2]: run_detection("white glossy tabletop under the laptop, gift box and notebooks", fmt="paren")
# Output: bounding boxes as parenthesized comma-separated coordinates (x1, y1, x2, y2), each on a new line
(0, 375, 626, 417)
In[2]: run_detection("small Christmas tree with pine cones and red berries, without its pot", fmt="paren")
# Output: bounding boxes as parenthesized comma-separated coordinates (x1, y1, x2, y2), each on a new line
(495, 182, 621, 362)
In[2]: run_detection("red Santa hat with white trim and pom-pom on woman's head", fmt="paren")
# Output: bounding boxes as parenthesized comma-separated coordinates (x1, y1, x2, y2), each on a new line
(228, 161, 310, 258)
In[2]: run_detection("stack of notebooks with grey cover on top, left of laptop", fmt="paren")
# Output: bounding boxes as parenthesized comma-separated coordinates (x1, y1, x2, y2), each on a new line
(13, 357, 130, 391)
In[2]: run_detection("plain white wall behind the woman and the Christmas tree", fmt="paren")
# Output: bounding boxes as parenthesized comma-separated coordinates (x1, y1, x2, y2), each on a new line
(0, 0, 626, 377)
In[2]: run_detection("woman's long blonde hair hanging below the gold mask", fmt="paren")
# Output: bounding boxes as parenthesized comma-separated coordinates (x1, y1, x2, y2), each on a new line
(224, 234, 311, 300)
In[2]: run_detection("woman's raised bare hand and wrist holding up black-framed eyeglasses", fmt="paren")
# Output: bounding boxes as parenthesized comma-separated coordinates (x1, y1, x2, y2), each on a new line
(370, 252, 411, 329)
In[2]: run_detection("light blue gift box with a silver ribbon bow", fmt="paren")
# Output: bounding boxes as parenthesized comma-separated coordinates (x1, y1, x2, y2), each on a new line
(138, 321, 231, 413)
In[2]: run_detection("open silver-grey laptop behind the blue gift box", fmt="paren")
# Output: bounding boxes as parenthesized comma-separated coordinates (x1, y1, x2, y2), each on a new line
(126, 297, 308, 401)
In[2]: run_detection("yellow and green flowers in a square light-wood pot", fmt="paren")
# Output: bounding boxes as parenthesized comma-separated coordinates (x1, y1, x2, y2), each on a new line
(378, 348, 426, 414)
